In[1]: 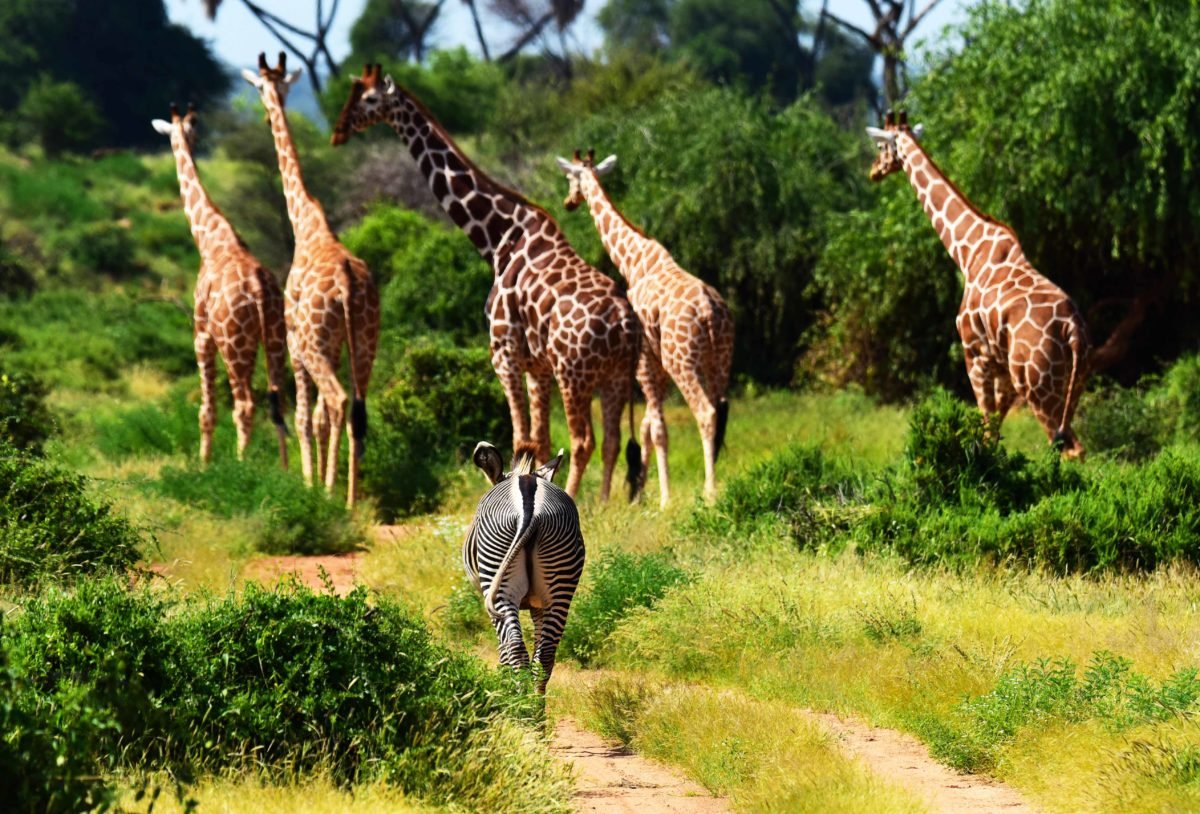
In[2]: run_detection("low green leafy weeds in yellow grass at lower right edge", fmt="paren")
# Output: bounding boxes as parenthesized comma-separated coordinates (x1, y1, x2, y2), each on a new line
(930, 652, 1200, 772)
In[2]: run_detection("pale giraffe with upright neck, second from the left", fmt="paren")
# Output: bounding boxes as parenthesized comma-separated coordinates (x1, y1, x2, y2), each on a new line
(242, 52, 379, 508)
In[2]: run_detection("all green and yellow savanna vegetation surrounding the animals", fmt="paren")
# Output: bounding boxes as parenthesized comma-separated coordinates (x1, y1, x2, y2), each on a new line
(0, 0, 1200, 812)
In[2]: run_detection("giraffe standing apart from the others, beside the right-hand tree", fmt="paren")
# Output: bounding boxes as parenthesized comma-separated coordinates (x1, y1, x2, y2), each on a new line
(866, 110, 1088, 459)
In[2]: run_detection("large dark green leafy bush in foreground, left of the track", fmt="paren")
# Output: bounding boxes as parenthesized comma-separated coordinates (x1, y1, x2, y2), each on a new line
(0, 581, 564, 810)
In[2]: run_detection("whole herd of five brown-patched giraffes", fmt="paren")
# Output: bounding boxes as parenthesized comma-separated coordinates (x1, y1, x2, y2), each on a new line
(154, 53, 1088, 516)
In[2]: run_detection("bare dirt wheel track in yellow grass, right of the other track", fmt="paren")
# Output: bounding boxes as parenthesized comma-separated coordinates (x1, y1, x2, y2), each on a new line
(809, 712, 1038, 814)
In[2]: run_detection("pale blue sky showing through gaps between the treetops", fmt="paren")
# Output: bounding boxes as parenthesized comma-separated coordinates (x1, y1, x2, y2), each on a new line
(167, 0, 968, 67)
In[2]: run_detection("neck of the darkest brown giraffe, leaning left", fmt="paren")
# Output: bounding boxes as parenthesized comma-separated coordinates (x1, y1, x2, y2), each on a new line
(385, 89, 532, 263)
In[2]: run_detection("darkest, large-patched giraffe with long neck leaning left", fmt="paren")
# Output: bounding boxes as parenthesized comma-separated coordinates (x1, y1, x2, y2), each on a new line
(332, 65, 641, 501)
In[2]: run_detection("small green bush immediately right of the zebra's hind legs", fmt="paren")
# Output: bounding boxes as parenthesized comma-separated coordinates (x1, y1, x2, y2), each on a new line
(559, 550, 688, 666)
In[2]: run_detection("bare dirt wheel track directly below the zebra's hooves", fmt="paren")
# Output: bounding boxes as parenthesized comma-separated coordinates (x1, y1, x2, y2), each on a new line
(551, 718, 732, 814)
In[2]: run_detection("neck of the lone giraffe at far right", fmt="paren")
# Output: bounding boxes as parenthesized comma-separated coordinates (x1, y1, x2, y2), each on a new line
(896, 132, 1012, 285)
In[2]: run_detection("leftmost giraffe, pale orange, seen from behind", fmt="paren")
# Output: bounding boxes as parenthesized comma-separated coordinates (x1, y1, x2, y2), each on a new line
(151, 104, 288, 469)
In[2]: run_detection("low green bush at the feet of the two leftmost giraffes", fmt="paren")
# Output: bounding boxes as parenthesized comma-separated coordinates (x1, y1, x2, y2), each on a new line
(144, 450, 366, 553)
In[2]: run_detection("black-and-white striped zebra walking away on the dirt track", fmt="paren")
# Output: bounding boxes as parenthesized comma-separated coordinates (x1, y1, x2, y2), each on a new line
(462, 441, 584, 694)
